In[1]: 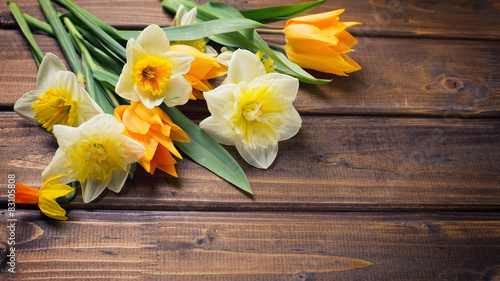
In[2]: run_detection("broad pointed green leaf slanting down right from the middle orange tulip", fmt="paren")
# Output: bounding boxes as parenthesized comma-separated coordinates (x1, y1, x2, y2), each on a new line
(160, 104, 252, 194)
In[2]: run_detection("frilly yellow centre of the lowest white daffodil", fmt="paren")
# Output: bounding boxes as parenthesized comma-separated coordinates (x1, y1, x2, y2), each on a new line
(65, 136, 127, 182)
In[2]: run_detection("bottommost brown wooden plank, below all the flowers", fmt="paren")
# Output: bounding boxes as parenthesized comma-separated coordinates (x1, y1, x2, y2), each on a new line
(0, 210, 500, 280)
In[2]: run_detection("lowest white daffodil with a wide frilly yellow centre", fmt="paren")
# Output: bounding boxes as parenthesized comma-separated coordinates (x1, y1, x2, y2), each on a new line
(42, 114, 144, 203)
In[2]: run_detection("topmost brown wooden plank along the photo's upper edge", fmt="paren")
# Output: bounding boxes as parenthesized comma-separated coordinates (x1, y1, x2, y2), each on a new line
(0, 0, 500, 40)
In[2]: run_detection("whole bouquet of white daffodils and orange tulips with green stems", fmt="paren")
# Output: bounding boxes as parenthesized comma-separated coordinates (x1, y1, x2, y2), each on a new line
(8, 0, 360, 220)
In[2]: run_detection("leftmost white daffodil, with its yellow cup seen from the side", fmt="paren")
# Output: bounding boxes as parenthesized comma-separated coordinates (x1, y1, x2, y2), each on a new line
(14, 53, 103, 132)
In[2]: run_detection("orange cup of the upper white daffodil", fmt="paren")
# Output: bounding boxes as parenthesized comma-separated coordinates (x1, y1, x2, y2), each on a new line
(134, 55, 172, 96)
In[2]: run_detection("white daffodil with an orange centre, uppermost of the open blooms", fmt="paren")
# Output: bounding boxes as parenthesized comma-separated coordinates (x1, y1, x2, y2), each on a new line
(116, 25, 194, 109)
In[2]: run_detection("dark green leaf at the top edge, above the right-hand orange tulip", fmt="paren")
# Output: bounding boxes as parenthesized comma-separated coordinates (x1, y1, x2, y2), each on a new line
(239, 0, 326, 23)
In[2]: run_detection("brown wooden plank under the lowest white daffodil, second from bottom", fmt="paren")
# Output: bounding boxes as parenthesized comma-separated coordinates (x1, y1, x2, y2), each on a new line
(0, 112, 500, 211)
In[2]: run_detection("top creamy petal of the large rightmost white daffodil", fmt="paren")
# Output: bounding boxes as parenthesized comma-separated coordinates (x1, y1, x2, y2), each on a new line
(227, 49, 266, 84)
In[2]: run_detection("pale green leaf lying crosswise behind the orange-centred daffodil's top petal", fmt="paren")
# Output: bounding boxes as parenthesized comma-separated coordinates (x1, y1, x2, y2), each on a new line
(117, 18, 265, 41)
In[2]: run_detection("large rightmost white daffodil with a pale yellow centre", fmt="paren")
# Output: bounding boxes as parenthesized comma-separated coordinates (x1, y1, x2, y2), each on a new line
(200, 49, 302, 169)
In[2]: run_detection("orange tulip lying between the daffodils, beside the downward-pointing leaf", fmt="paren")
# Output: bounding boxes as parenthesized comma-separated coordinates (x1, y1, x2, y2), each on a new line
(115, 102, 189, 177)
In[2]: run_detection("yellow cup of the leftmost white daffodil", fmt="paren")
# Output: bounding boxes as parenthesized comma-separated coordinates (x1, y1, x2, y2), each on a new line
(31, 87, 76, 132)
